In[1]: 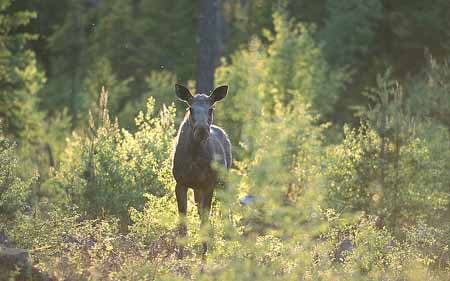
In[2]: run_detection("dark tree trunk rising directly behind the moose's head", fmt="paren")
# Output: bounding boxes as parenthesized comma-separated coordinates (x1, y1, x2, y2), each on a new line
(196, 0, 222, 93)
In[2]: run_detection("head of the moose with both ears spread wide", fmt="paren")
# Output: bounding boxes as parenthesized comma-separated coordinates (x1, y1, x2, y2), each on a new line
(175, 84, 228, 143)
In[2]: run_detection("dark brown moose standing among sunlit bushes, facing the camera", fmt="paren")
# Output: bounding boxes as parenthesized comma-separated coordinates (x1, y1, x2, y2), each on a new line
(172, 84, 231, 257)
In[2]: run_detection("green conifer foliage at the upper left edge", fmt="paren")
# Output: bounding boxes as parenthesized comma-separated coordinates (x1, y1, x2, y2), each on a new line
(0, 0, 45, 143)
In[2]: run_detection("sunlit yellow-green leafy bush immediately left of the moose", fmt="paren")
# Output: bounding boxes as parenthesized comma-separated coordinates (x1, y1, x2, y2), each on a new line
(47, 92, 175, 226)
